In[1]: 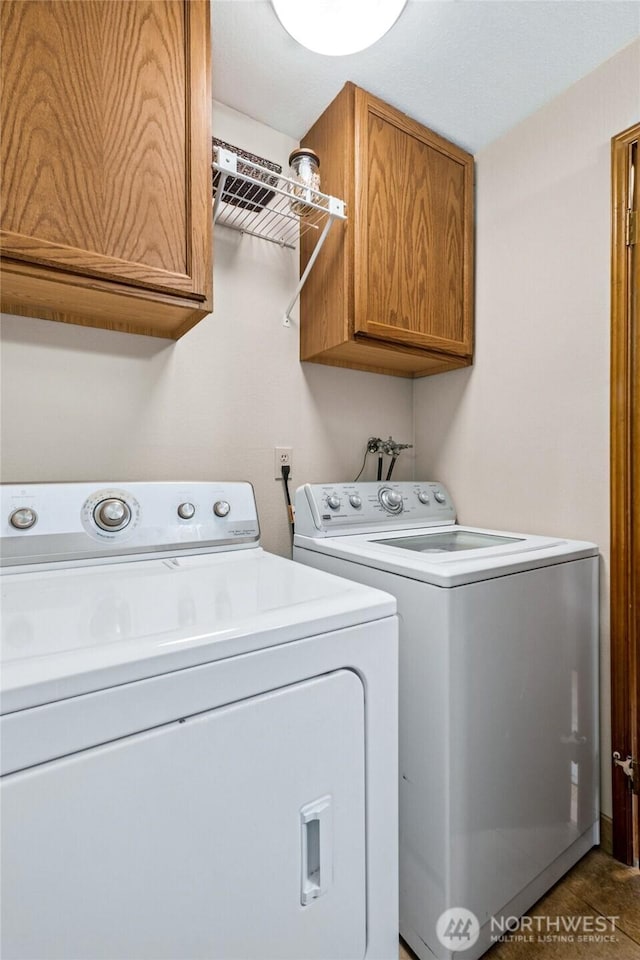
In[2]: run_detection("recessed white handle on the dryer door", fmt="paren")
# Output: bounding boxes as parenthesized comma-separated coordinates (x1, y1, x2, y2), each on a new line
(300, 795, 333, 907)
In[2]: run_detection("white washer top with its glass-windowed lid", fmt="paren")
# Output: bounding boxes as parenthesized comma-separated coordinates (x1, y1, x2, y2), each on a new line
(295, 524, 598, 587)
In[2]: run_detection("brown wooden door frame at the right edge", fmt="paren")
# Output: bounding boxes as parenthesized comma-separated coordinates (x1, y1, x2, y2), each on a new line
(610, 118, 640, 864)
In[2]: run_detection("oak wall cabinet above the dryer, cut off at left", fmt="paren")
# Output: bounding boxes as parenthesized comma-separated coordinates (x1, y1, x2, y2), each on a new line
(0, 0, 212, 338)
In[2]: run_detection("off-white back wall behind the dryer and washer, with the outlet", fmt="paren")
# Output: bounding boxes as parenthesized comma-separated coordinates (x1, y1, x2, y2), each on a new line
(1, 104, 413, 554)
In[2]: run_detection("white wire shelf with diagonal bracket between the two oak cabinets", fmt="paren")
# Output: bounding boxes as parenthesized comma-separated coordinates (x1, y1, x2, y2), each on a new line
(212, 147, 347, 327)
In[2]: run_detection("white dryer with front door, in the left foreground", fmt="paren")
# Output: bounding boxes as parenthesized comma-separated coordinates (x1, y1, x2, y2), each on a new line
(0, 483, 398, 960)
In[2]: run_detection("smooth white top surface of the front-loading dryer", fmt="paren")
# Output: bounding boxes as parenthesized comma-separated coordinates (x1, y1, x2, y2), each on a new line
(0, 547, 396, 713)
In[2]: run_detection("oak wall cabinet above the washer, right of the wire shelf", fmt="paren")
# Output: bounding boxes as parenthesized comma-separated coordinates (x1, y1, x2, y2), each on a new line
(300, 83, 473, 377)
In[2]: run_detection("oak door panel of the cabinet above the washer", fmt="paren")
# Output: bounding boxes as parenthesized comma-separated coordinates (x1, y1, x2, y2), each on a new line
(350, 89, 473, 356)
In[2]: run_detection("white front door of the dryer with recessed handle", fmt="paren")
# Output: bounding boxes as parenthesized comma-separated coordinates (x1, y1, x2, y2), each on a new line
(2, 670, 366, 960)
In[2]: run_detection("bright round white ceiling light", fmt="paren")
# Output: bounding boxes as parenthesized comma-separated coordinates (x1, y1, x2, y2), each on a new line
(271, 0, 407, 57)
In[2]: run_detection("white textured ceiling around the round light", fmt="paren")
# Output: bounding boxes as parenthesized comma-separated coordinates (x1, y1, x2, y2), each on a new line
(212, 0, 640, 153)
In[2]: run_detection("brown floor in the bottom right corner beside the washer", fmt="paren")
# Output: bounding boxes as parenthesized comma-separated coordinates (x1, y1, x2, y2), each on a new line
(400, 847, 640, 960)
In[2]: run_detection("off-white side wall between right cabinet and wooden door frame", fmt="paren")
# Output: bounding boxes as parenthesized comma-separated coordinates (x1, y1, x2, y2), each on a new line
(414, 42, 640, 814)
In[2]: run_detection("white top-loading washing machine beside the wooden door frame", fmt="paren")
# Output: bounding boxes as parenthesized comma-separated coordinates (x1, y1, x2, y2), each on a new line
(294, 482, 599, 960)
